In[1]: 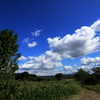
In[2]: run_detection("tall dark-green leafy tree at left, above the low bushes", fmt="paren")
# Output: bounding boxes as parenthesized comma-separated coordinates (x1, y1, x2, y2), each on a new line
(0, 29, 21, 74)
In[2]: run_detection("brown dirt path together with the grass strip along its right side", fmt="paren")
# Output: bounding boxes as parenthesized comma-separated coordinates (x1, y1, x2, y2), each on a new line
(65, 84, 100, 100)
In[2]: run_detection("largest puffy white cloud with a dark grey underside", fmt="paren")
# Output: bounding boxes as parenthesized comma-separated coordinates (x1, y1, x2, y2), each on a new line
(47, 26, 100, 59)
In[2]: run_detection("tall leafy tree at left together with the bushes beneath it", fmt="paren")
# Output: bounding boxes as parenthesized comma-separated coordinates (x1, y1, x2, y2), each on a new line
(0, 29, 21, 100)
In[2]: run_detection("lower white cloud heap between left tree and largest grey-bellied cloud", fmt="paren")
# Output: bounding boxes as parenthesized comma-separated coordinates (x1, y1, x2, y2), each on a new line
(20, 54, 62, 70)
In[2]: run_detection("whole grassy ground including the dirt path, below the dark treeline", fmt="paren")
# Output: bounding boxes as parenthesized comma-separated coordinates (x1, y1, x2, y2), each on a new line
(0, 79, 100, 100)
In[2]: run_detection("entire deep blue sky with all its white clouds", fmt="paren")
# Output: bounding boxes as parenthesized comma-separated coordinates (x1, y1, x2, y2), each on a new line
(0, 0, 100, 76)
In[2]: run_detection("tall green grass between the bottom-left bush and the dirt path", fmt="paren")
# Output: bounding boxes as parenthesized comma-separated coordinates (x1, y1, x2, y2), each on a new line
(18, 81, 80, 100)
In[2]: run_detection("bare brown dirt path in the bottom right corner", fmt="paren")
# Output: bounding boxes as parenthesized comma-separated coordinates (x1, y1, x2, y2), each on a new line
(67, 88, 100, 100)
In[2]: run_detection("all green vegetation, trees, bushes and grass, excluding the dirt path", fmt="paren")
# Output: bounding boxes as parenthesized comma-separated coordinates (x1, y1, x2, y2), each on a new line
(0, 29, 100, 100)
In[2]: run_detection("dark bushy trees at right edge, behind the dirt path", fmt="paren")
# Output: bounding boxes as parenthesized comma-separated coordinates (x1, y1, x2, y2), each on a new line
(74, 67, 100, 85)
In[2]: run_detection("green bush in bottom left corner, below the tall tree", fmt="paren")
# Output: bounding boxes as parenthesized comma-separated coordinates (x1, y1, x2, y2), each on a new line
(0, 75, 19, 100)
